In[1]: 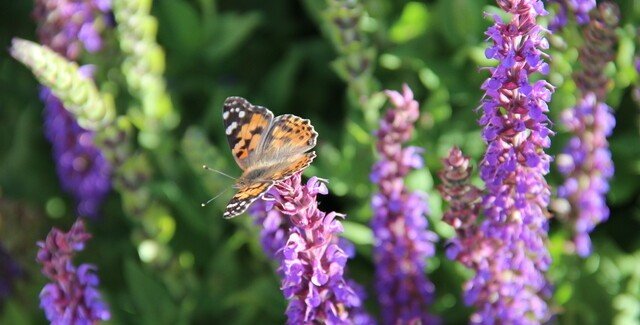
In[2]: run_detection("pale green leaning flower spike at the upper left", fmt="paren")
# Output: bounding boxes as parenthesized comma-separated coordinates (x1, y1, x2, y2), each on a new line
(10, 38, 115, 131)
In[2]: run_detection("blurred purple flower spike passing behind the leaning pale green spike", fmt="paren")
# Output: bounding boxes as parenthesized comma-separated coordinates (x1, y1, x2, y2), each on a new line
(33, 0, 111, 218)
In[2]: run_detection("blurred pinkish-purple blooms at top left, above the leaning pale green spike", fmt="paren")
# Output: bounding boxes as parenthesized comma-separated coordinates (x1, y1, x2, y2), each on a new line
(33, 0, 111, 60)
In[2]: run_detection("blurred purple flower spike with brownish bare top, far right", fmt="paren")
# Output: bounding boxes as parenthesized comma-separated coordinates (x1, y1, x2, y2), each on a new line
(557, 2, 620, 257)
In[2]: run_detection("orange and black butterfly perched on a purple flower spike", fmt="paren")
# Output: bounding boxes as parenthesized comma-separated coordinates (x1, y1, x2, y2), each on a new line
(222, 97, 318, 219)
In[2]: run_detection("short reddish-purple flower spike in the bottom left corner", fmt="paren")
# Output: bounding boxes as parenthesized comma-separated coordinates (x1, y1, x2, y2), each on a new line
(37, 219, 111, 325)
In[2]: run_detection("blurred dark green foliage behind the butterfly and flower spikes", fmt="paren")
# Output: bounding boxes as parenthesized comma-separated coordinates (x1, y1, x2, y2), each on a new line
(0, 0, 640, 324)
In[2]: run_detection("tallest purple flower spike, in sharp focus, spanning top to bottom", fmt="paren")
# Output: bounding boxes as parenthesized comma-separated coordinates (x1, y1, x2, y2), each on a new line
(478, 0, 553, 324)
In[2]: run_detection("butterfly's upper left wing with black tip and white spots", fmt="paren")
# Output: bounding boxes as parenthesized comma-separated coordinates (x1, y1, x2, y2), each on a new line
(222, 97, 273, 170)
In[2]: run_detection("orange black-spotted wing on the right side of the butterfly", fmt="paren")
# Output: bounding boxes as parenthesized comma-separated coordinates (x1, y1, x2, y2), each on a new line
(266, 114, 318, 152)
